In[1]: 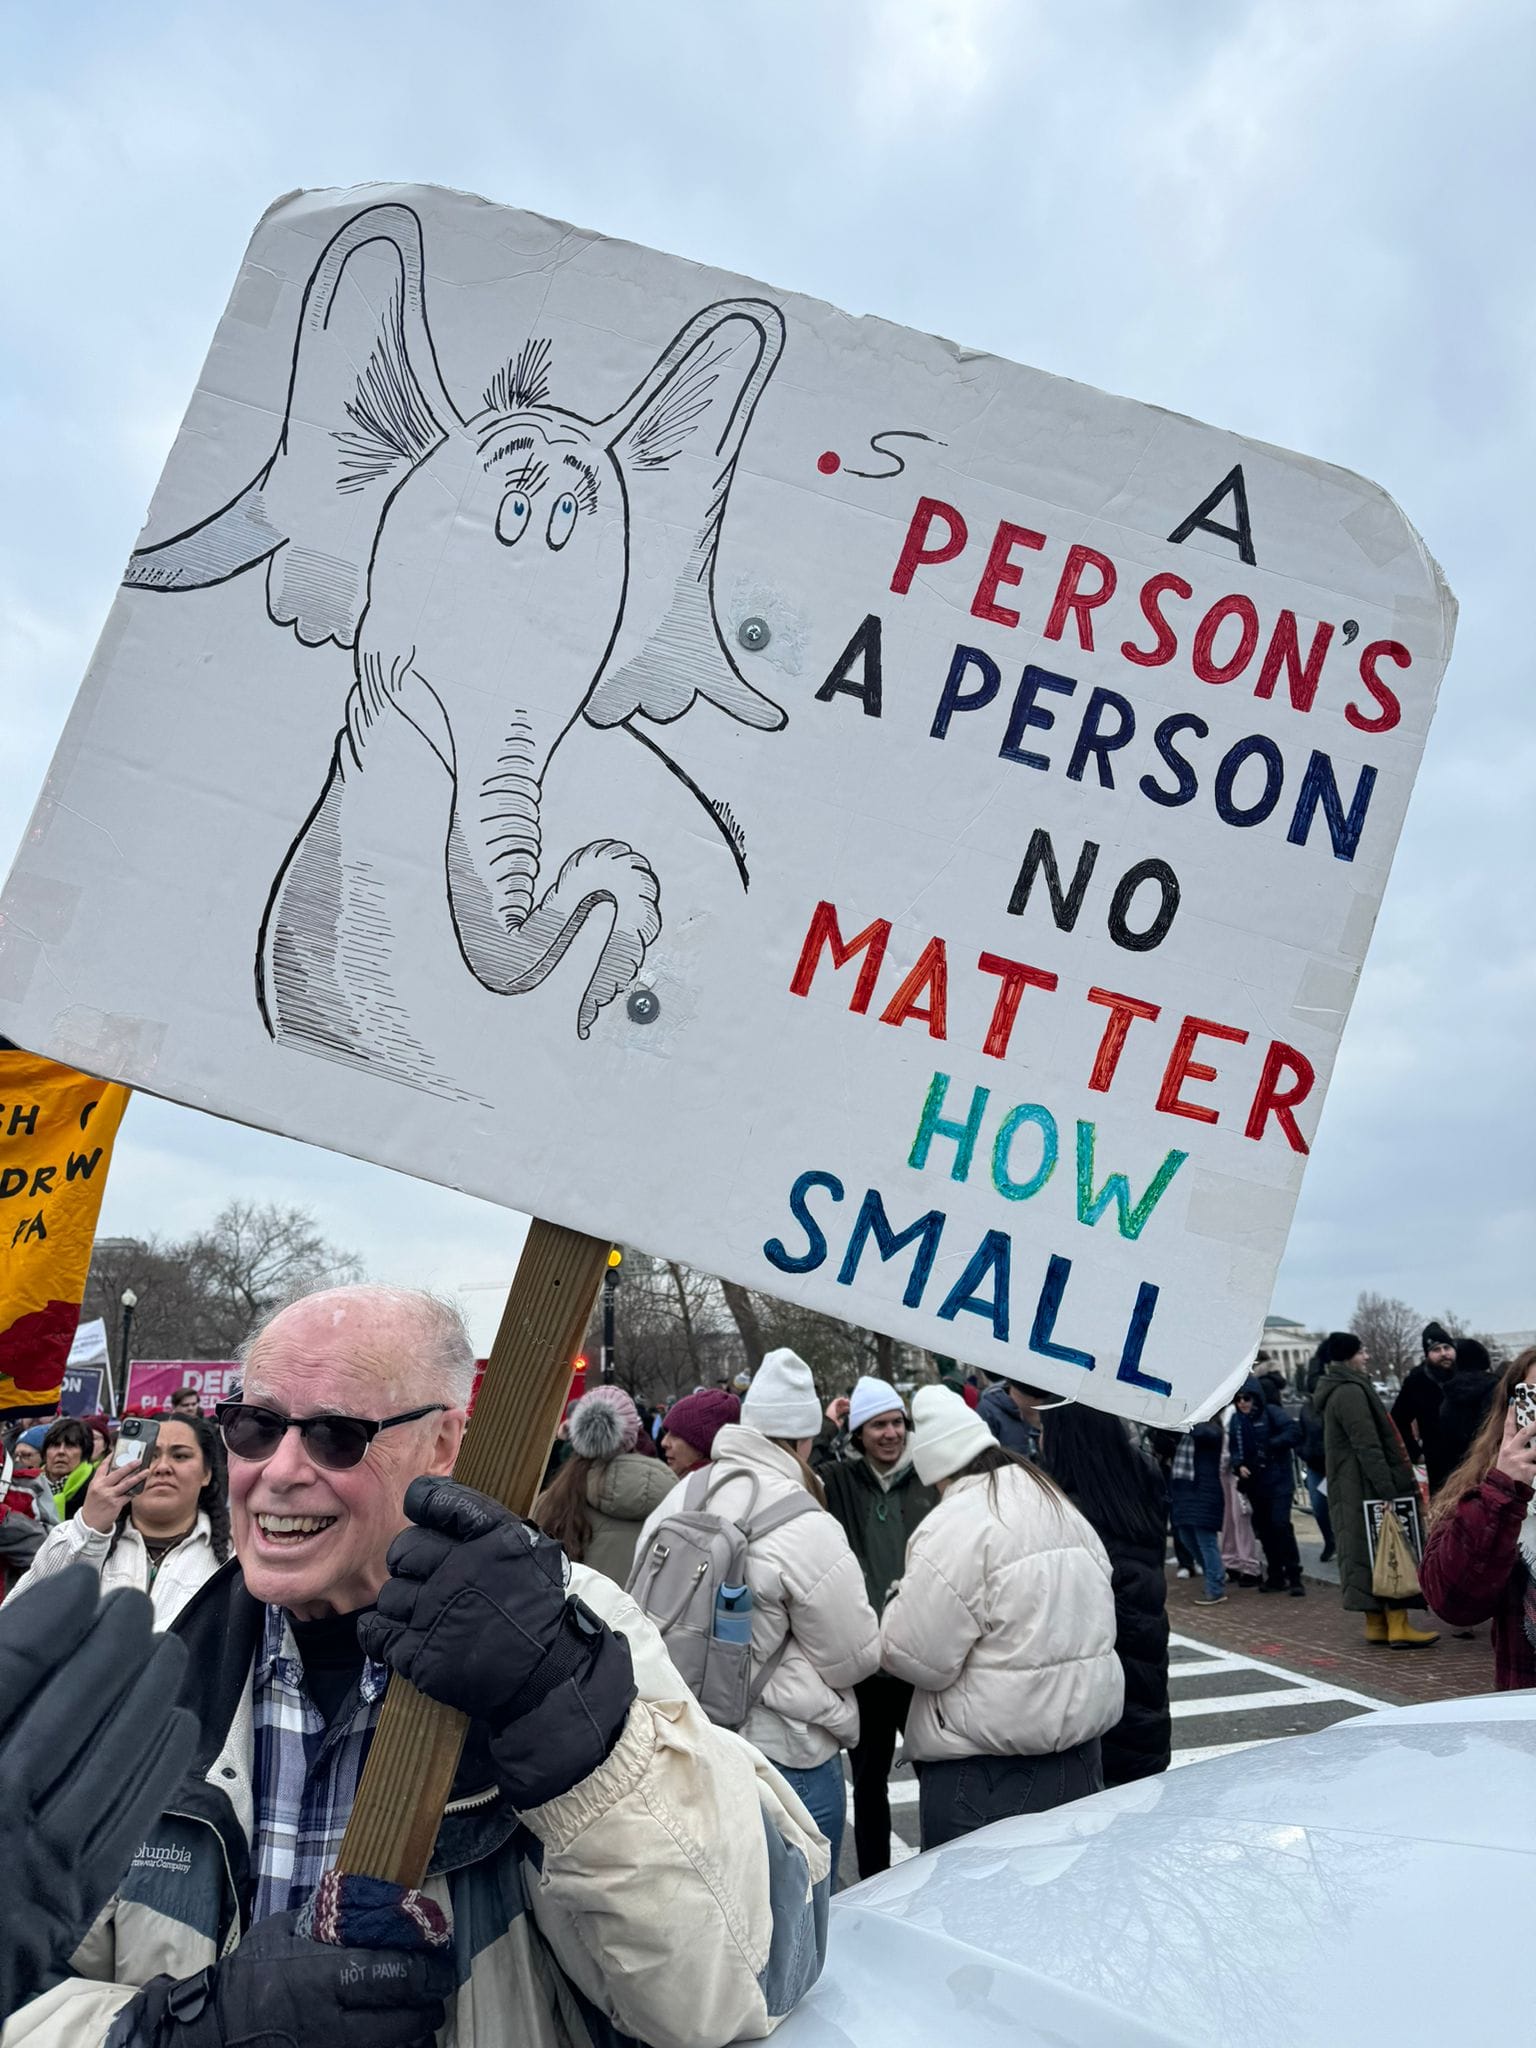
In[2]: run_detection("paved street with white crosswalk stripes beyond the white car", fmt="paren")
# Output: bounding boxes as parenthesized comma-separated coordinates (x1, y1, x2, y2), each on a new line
(842, 1530, 1493, 1884)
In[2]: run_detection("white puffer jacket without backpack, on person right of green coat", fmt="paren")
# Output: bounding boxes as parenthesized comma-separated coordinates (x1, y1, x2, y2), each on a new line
(881, 1468, 1124, 1763)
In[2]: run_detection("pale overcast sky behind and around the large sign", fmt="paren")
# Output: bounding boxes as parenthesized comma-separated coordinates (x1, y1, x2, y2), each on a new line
(0, 0, 1536, 1339)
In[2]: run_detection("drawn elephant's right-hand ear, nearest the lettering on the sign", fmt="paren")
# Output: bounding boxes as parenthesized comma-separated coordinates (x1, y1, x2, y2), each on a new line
(586, 299, 784, 731)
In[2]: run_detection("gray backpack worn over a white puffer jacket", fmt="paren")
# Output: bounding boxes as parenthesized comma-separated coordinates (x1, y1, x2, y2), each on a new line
(629, 1470, 819, 1729)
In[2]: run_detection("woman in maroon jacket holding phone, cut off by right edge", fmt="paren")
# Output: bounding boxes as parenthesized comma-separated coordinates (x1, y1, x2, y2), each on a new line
(1419, 1346, 1536, 1692)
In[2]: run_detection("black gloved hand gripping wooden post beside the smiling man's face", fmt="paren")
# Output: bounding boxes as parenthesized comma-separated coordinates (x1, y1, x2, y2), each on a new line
(358, 1479, 635, 1808)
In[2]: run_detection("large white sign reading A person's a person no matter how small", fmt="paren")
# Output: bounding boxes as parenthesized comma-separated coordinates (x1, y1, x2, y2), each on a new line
(0, 188, 1454, 1423)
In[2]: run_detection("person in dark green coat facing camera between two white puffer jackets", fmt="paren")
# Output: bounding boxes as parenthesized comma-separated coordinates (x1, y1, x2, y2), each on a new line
(819, 1378, 938, 1878)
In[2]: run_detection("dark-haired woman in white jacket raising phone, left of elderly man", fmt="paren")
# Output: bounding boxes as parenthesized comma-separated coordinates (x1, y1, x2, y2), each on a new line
(6, 1415, 229, 1628)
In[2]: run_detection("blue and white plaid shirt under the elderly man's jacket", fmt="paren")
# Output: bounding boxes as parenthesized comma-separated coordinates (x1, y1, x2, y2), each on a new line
(252, 1608, 389, 1919)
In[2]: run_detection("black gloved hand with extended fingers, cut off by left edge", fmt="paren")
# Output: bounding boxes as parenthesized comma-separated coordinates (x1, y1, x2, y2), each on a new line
(0, 1565, 197, 2021)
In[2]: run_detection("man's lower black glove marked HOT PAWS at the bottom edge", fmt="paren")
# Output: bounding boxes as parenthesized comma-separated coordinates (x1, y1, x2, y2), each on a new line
(109, 1913, 457, 2048)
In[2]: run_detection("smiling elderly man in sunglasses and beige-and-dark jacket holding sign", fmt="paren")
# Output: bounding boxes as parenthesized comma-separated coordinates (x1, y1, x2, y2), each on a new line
(4, 1286, 827, 2048)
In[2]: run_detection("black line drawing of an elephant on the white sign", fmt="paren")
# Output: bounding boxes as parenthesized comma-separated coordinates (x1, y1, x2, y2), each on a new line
(125, 205, 784, 1092)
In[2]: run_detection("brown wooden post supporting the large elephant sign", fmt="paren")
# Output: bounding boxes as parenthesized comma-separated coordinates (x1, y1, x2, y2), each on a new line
(336, 1219, 608, 1884)
